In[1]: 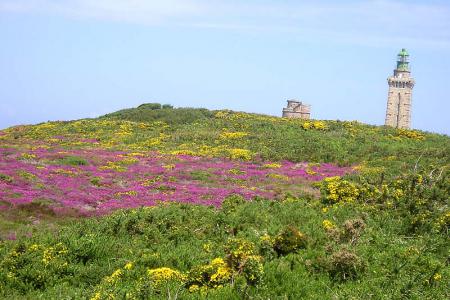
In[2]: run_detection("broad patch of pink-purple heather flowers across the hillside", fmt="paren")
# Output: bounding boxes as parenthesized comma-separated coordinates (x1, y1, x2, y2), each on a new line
(0, 146, 351, 215)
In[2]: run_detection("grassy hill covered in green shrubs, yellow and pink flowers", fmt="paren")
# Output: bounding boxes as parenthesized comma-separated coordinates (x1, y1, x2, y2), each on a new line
(0, 104, 450, 299)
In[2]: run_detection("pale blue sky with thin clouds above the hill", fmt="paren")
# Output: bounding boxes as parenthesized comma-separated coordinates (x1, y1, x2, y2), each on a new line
(0, 0, 450, 134)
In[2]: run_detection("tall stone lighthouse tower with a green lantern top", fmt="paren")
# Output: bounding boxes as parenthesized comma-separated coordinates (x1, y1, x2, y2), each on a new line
(385, 49, 414, 129)
